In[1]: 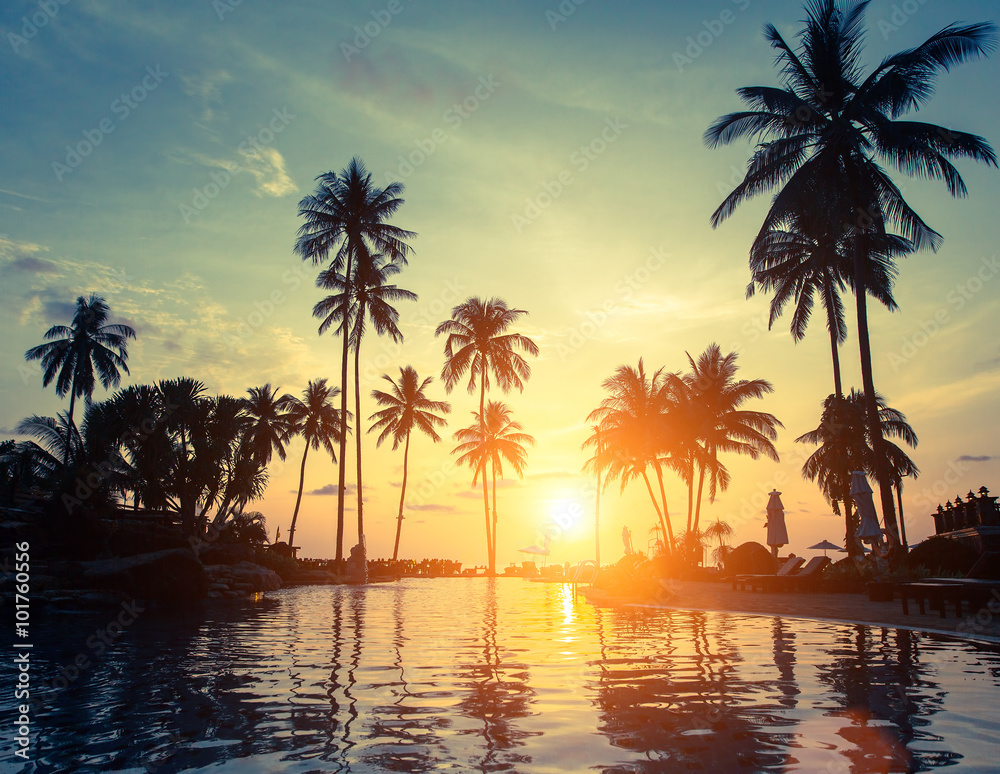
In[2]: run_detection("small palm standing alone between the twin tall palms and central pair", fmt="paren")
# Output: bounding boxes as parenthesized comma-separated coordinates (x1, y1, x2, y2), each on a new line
(368, 366, 451, 561)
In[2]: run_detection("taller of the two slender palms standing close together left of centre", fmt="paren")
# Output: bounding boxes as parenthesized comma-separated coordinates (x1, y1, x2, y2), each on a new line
(295, 158, 416, 562)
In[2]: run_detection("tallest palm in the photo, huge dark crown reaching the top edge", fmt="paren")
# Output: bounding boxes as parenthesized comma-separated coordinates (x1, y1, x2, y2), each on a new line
(705, 0, 997, 544)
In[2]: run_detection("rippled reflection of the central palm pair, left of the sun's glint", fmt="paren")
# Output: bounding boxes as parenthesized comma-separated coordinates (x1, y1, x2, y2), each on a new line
(458, 578, 541, 771)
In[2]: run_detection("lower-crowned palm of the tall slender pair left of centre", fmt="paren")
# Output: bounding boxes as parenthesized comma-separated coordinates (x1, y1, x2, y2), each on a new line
(313, 254, 417, 543)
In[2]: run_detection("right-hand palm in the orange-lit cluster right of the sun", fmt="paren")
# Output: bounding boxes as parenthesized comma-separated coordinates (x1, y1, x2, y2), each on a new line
(684, 344, 784, 534)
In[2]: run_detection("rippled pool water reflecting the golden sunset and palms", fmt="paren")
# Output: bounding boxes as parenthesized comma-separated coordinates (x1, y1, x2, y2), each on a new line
(0, 579, 1000, 774)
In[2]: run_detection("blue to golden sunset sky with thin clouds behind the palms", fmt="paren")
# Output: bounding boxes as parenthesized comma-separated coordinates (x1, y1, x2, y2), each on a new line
(0, 0, 1000, 567)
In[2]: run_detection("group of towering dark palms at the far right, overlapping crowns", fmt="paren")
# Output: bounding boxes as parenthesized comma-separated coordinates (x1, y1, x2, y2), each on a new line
(705, 0, 997, 547)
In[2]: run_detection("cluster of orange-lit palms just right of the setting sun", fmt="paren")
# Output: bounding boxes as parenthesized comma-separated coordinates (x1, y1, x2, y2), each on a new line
(584, 344, 782, 559)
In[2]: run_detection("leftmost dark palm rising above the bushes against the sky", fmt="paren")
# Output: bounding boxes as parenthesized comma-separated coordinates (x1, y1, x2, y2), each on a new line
(24, 295, 135, 463)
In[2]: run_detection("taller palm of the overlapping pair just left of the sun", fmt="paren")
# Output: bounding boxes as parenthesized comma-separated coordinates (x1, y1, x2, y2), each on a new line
(434, 296, 538, 572)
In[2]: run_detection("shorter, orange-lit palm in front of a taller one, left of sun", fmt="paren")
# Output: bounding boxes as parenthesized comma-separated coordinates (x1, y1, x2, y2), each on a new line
(452, 400, 535, 575)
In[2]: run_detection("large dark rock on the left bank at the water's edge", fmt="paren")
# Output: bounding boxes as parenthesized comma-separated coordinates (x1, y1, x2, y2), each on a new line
(79, 548, 208, 606)
